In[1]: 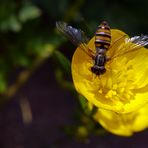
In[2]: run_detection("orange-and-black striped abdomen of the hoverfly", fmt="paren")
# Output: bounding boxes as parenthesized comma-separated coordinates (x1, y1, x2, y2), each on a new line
(95, 21, 111, 50)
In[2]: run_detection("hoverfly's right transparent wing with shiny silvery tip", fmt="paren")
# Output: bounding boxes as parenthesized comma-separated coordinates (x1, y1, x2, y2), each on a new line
(110, 35, 148, 59)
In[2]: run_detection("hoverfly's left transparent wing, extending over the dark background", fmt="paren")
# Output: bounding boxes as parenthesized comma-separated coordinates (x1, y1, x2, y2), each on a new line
(56, 21, 95, 58)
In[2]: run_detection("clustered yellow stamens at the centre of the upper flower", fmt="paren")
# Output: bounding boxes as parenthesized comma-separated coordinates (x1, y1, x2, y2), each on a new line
(95, 73, 134, 104)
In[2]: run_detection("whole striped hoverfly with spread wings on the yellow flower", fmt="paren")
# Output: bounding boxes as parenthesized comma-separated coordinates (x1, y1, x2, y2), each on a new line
(56, 21, 148, 75)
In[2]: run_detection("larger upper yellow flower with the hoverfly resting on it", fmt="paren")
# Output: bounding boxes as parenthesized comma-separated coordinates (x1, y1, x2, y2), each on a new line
(72, 29, 148, 113)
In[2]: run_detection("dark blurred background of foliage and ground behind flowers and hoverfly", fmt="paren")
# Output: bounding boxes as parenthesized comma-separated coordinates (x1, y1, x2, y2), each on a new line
(0, 0, 148, 148)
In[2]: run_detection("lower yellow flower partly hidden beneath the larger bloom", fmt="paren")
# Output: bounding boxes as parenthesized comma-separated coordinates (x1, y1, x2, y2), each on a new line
(94, 104, 148, 136)
